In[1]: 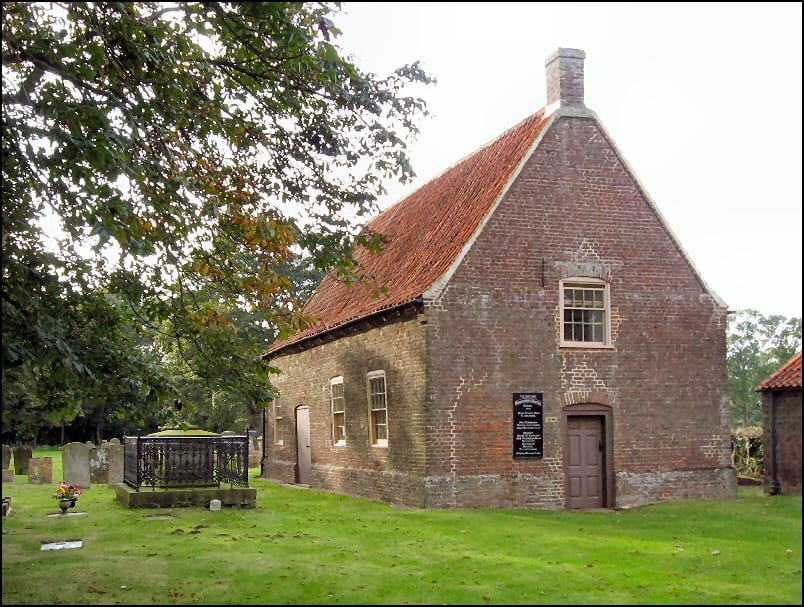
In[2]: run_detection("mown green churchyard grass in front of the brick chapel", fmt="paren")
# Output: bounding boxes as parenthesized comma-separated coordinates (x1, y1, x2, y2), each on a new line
(2, 449, 802, 605)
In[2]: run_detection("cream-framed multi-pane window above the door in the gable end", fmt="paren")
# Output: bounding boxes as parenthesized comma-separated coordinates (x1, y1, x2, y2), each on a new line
(559, 277, 611, 348)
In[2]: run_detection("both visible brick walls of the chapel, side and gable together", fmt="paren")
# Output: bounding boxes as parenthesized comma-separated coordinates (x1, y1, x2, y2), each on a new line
(266, 113, 736, 508)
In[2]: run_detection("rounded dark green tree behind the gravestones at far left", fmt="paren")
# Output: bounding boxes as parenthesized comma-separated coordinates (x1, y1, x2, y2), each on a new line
(3, 281, 166, 442)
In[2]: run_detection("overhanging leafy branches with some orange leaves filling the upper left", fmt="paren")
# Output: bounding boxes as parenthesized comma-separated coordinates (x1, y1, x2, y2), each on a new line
(2, 2, 432, 436)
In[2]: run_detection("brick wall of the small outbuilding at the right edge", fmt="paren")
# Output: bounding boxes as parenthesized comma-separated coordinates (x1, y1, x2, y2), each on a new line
(762, 389, 801, 495)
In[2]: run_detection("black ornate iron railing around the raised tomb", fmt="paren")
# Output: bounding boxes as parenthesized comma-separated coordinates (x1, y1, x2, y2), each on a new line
(123, 436, 249, 491)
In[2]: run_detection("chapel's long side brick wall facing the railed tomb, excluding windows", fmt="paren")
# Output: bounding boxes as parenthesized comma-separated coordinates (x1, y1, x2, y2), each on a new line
(265, 314, 426, 507)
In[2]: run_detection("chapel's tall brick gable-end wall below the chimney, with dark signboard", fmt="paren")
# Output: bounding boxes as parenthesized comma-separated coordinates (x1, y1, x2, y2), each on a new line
(427, 118, 736, 508)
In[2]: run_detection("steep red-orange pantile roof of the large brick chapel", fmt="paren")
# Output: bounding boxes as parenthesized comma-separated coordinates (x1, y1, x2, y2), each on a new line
(266, 110, 547, 355)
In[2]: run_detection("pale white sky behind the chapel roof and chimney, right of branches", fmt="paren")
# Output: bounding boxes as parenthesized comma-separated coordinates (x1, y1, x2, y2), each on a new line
(334, 2, 802, 317)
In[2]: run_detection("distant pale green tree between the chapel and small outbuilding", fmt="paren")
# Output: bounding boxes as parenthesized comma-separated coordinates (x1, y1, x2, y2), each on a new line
(727, 310, 801, 428)
